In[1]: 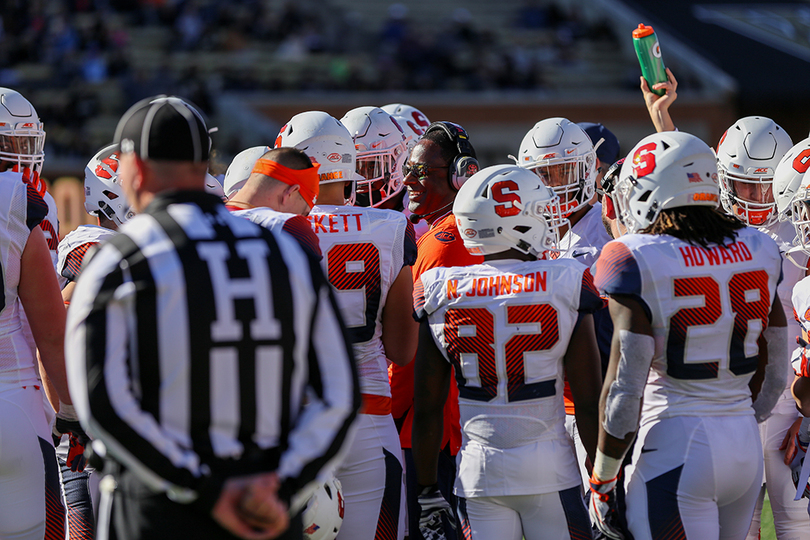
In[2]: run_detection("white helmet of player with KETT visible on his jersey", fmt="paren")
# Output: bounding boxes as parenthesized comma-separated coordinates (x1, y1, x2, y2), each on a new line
(274, 111, 363, 204)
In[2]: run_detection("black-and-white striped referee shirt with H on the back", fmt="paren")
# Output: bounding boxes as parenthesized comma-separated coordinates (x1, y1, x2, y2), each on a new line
(66, 192, 360, 509)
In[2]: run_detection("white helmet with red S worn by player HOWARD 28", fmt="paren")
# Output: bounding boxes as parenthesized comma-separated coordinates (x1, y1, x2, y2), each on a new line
(613, 131, 720, 234)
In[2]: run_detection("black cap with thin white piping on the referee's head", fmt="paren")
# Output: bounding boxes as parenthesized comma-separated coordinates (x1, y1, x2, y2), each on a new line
(115, 95, 211, 163)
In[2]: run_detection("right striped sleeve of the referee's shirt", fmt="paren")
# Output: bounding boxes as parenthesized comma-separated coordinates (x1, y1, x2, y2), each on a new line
(278, 262, 361, 508)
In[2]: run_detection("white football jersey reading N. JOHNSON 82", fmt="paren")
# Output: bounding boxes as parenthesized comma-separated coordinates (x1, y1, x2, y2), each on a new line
(414, 259, 602, 497)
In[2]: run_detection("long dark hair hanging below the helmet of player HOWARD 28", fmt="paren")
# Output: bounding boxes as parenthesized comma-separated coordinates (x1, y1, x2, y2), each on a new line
(641, 206, 745, 248)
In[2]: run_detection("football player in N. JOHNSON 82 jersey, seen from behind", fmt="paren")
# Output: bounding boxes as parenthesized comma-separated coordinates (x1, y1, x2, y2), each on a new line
(413, 165, 602, 540)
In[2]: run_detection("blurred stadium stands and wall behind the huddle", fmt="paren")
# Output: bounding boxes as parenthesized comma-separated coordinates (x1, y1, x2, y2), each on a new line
(0, 0, 810, 538)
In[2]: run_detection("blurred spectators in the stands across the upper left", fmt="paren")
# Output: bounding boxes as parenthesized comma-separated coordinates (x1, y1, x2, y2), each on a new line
(0, 0, 620, 157)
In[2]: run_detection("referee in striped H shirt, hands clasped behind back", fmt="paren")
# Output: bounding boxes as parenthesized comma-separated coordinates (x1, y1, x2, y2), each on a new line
(66, 96, 360, 539)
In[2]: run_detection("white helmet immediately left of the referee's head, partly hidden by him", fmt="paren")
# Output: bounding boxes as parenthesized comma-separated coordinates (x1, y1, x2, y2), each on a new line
(84, 144, 135, 226)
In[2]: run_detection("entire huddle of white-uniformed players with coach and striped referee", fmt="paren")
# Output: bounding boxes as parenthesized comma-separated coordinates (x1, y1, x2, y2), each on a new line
(0, 73, 810, 540)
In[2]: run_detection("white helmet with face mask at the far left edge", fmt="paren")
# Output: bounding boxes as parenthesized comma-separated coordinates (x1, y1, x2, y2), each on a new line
(0, 88, 45, 172)
